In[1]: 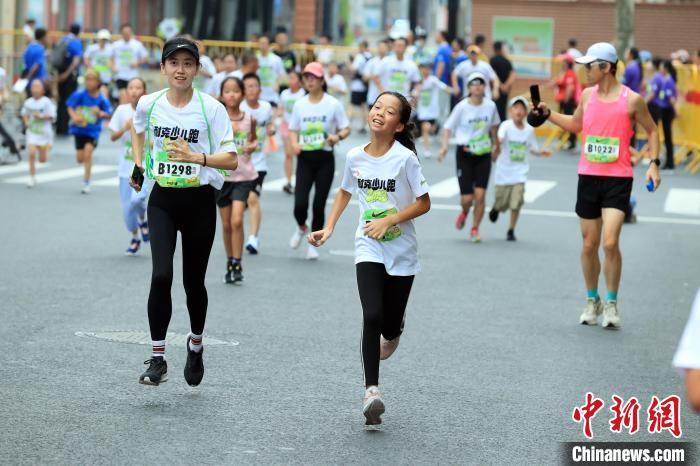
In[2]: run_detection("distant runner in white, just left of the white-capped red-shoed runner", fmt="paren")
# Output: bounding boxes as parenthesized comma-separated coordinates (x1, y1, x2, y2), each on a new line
(413, 59, 459, 158)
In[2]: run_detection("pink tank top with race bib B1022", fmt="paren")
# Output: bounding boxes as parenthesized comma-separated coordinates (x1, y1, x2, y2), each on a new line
(578, 86, 634, 178)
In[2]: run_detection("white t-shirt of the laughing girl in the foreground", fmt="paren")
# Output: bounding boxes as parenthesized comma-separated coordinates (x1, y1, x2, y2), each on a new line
(341, 141, 428, 276)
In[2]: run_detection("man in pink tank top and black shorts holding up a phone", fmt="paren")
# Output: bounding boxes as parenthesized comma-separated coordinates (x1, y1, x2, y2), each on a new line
(538, 42, 661, 328)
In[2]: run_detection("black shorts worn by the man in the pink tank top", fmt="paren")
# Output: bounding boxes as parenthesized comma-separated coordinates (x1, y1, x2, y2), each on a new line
(576, 175, 634, 220)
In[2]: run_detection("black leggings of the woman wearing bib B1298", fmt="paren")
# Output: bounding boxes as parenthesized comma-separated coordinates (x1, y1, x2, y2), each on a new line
(148, 184, 216, 340)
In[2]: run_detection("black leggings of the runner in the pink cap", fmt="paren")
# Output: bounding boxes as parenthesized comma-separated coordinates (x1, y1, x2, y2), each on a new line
(294, 150, 335, 231)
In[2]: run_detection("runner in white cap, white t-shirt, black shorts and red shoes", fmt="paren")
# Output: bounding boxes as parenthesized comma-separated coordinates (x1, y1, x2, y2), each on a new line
(438, 71, 501, 243)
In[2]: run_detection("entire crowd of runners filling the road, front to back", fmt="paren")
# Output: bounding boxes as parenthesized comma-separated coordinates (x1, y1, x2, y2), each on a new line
(0, 21, 700, 425)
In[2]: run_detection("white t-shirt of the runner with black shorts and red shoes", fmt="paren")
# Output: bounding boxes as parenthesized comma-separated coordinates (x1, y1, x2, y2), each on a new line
(443, 99, 501, 148)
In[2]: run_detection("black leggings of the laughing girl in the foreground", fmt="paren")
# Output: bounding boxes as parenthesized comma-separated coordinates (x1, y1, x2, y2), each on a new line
(355, 262, 413, 387)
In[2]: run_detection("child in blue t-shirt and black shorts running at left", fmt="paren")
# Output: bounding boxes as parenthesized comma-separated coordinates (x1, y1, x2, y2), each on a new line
(66, 69, 112, 194)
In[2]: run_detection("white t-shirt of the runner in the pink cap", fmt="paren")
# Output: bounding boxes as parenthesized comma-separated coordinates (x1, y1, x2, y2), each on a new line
(289, 93, 350, 151)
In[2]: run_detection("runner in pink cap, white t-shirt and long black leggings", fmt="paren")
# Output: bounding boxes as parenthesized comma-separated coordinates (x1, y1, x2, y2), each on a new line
(289, 62, 350, 259)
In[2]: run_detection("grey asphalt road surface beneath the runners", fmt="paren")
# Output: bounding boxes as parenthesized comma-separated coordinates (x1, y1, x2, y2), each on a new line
(0, 126, 700, 465)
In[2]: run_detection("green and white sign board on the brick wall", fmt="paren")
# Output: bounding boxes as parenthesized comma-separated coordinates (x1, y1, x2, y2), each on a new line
(492, 16, 554, 79)
